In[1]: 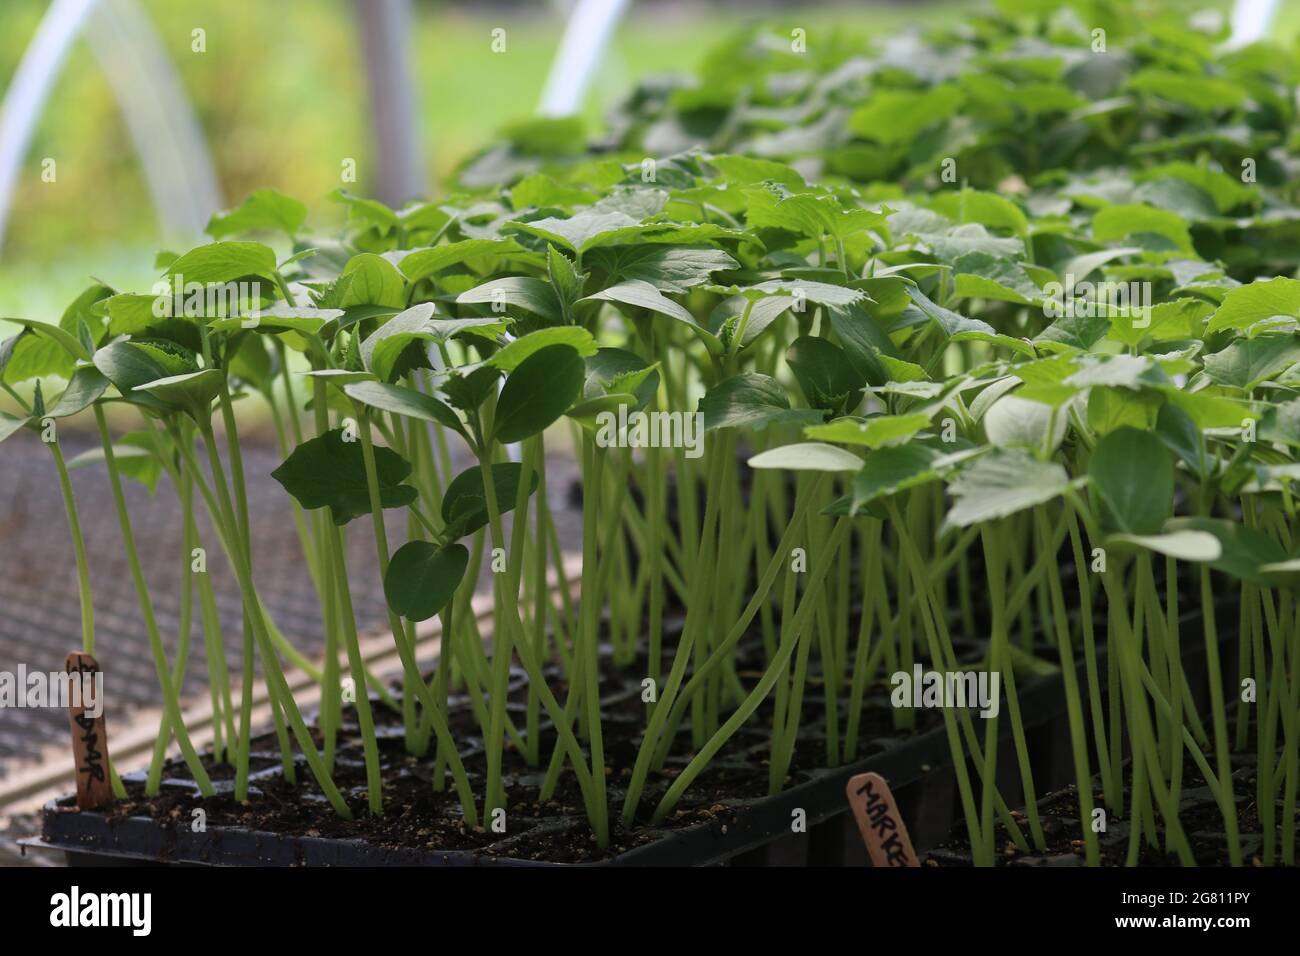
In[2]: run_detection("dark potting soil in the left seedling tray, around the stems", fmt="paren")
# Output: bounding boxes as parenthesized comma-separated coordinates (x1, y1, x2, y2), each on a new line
(89, 629, 943, 862)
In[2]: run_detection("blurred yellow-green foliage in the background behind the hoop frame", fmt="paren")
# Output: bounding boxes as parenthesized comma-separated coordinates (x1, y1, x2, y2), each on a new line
(0, 0, 1258, 319)
